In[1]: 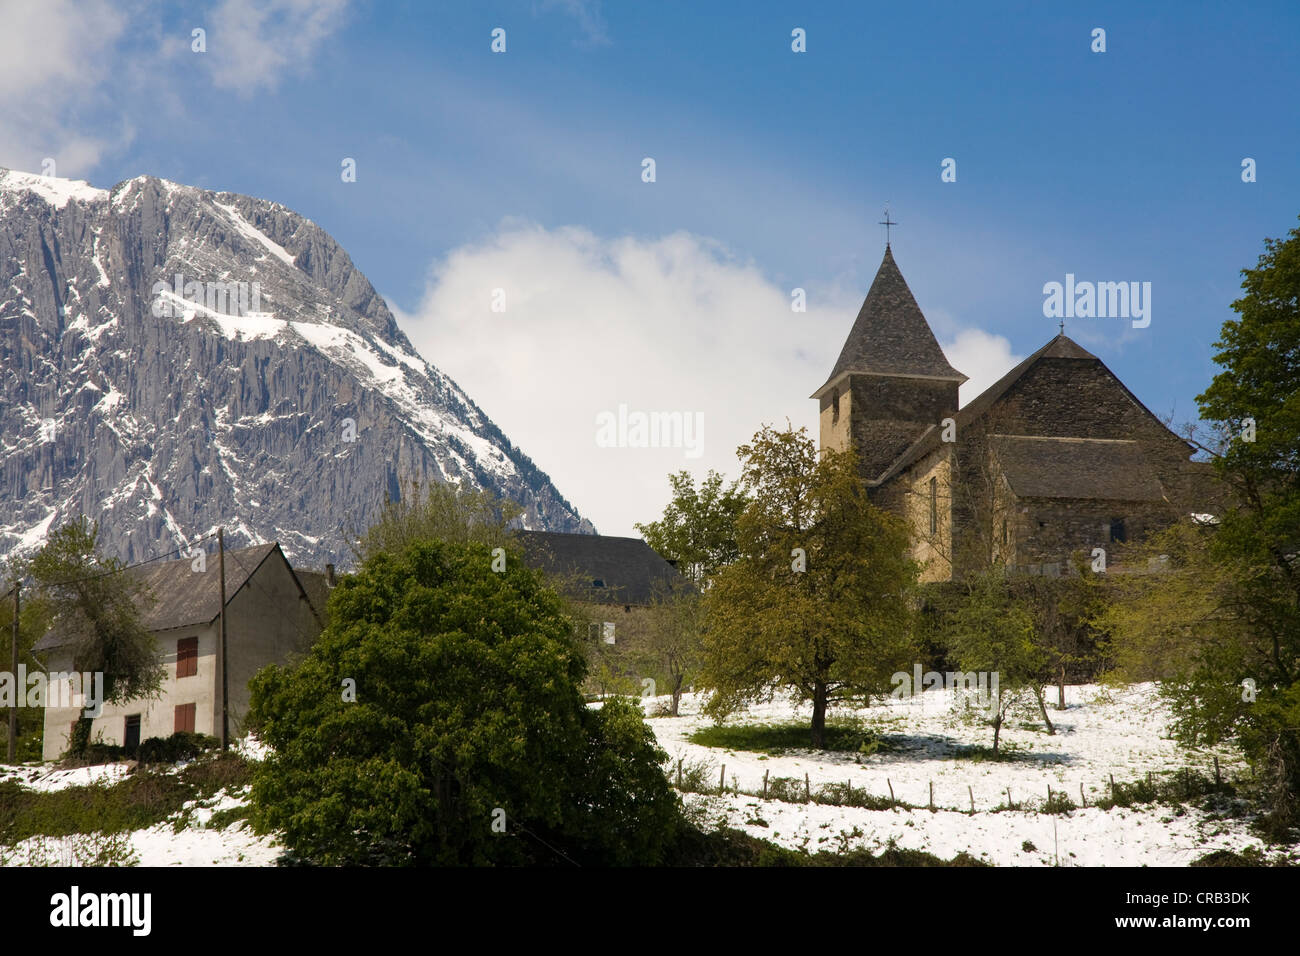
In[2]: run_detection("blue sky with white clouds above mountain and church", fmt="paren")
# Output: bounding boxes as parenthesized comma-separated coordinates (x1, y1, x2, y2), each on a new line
(0, 0, 1300, 533)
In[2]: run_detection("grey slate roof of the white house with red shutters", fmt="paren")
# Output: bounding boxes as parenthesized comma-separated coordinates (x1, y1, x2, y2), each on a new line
(33, 542, 306, 652)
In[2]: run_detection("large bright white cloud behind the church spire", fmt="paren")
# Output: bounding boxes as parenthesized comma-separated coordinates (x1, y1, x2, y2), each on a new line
(390, 222, 1018, 535)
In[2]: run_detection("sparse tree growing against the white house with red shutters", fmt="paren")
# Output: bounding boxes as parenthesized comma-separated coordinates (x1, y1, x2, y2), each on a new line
(23, 518, 165, 739)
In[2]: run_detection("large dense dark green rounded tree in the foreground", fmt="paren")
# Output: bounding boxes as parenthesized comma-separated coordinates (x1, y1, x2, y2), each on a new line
(250, 541, 680, 865)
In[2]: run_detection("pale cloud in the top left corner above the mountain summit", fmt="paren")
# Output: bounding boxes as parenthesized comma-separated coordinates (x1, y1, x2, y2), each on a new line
(0, 0, 130, 176)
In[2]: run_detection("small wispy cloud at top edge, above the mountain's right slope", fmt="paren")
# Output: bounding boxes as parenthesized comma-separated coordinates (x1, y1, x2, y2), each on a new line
(206, 0, 348, 96)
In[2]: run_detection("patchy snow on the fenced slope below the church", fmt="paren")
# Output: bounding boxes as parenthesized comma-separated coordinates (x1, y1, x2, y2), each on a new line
(647, 684, 1284, 866)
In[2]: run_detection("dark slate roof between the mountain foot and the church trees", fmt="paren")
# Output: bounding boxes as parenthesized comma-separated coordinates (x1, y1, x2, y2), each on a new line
(517, 531, 688, 605)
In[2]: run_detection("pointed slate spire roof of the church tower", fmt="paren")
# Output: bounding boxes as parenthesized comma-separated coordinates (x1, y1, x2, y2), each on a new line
(813, 243, 966, 398)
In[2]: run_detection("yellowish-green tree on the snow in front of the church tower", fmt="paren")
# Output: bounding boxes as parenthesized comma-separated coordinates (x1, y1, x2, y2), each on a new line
(701, 427, 917, 748)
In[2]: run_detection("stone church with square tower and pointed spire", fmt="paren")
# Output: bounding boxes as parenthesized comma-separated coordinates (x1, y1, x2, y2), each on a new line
(813, 245, 1212, 580)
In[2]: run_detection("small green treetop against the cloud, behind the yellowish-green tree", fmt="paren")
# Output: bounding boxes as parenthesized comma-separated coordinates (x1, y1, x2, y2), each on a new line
(634, 471, 746, 584)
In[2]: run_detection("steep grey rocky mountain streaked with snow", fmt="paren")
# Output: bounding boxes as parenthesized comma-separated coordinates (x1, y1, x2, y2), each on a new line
(0, 170, 594, 566)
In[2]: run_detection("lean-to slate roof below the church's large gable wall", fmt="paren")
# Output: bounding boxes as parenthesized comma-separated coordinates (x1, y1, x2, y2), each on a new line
(991, 434, 1165, 501)
